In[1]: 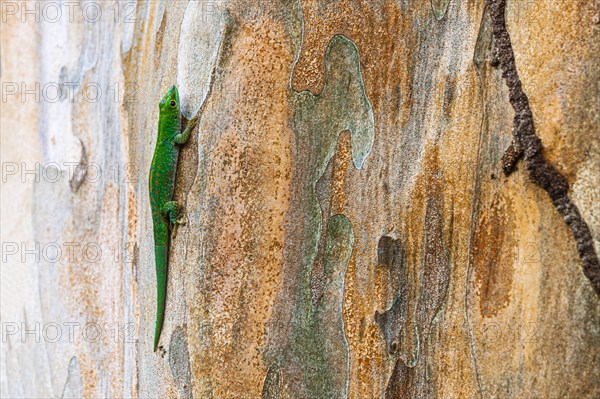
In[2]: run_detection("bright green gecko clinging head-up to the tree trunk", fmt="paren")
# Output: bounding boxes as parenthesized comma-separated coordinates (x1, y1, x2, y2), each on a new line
(149, 86, 198, 352)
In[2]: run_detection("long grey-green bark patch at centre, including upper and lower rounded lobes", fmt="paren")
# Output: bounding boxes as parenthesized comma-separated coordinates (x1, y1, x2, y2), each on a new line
(265, 35, 375, 398)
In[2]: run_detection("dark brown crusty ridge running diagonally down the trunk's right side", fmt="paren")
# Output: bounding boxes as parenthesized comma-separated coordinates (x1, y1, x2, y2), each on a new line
(487, 0, 600, 295)
